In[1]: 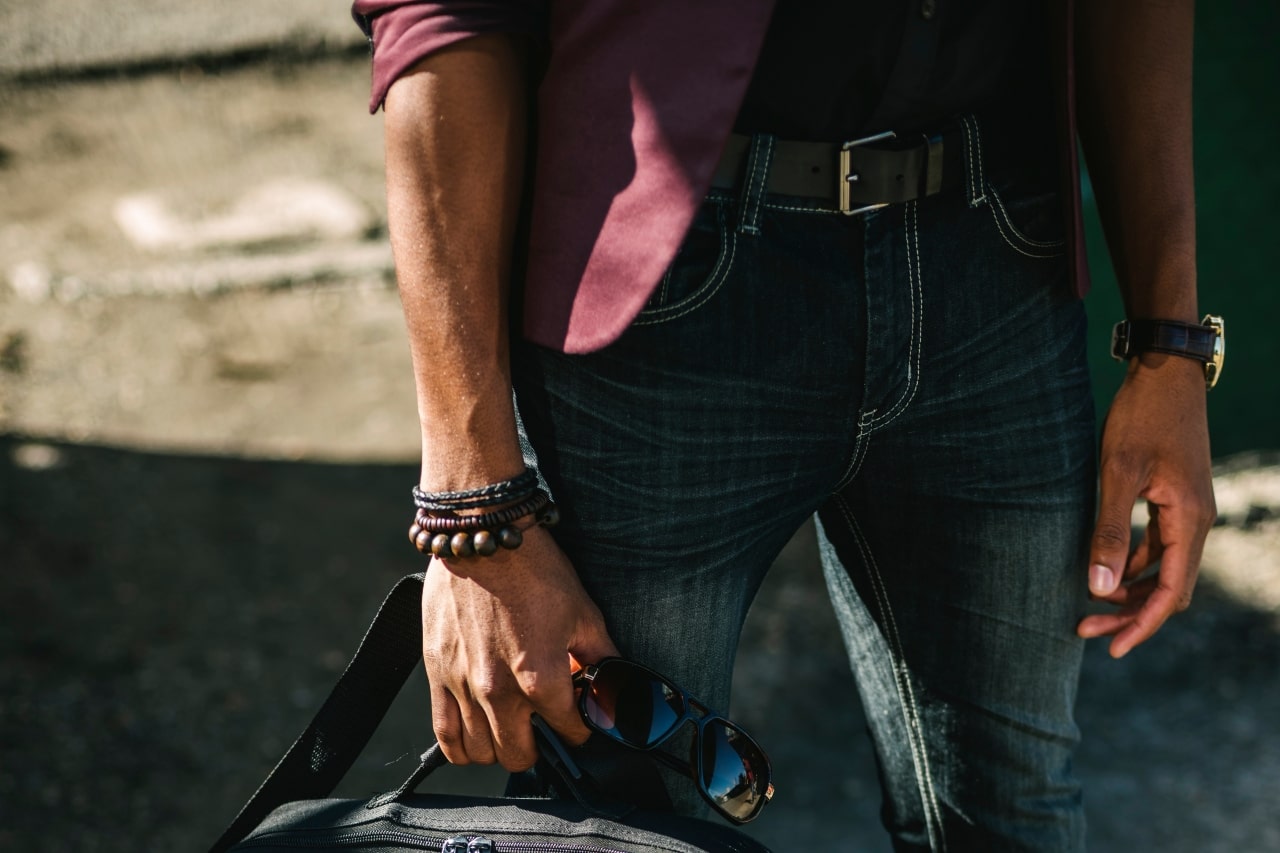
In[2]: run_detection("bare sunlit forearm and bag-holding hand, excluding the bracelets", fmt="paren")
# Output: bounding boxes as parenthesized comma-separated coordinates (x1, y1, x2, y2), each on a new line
(385, 35, 617, 771)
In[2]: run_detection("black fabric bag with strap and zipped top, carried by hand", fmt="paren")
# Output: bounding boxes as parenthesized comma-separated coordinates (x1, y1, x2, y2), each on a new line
(211, 575, 768, 853)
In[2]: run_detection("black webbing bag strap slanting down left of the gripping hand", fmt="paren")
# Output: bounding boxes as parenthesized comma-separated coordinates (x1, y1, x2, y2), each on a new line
(210, 574, 422, 853)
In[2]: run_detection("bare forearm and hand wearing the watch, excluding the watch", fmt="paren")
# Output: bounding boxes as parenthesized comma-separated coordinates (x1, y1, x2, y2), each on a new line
(1076, 0, 1215, 657)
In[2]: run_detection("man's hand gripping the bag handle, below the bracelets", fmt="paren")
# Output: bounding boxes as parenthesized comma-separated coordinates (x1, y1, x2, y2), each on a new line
(422, 526, 618, 772)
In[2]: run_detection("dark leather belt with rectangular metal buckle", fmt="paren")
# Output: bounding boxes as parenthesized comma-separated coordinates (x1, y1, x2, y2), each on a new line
(712, 126, 965, 215)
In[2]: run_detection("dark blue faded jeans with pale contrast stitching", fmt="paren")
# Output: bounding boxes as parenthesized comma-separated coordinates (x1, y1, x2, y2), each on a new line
(513, 119, 1094, 850)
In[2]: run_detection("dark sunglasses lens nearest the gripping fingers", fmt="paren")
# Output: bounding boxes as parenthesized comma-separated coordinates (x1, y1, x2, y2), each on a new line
(584, 661, 685, 749)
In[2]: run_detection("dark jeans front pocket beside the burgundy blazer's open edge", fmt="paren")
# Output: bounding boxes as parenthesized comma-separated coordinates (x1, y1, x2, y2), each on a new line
(635, 199, 737, 325)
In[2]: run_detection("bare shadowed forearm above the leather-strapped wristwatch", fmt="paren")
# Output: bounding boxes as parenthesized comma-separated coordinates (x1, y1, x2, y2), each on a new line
(1076, 0, 1198, 321)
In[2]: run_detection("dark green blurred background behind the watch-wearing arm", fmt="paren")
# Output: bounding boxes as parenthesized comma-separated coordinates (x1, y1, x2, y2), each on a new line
(1085, 0, 1280, 457)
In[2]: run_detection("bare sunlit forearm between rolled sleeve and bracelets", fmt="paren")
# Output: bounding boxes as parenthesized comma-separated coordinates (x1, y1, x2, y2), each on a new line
(385, 35, 526, 489)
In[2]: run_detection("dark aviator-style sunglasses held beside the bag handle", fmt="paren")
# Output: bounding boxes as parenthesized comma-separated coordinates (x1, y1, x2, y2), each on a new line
(573, 657, 773, 824)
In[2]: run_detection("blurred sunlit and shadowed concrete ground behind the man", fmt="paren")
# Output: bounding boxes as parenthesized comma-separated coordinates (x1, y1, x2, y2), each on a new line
(0, 0, 1280, 850)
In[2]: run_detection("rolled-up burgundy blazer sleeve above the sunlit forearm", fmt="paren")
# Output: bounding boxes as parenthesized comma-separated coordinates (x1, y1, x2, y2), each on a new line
(351, 0, 547, 113)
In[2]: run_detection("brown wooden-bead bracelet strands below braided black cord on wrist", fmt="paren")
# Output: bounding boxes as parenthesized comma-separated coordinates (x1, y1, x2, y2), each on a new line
(408, 489, 559, 560)
